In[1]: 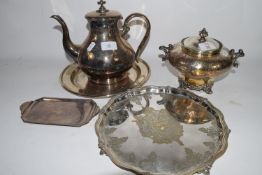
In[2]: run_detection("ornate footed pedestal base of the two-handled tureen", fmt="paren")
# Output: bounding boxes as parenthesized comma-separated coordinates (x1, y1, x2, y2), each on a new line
(178, 78, 214, 94)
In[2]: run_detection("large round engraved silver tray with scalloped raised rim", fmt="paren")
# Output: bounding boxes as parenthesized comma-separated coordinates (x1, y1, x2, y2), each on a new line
(96, 86, 230, 175)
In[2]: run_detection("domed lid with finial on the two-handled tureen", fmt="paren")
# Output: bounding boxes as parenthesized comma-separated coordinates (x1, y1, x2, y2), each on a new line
(181, 28, 223, 56)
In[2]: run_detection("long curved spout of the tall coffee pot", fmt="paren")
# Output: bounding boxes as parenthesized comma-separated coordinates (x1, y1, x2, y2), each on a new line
(50, 15, 80, 62)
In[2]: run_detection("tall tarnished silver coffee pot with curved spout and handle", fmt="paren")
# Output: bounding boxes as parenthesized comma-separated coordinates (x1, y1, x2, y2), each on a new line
(51, 0, 151, 81)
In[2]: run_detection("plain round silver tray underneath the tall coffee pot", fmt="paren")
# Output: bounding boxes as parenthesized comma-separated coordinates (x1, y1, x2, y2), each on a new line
(60, 59, 150, 98)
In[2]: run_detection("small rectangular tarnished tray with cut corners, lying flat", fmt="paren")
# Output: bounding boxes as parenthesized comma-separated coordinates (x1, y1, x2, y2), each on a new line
(20, 97, 99, 127)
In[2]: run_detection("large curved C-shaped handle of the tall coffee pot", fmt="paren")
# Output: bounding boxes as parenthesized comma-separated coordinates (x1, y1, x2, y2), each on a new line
(122, 13, 151, 62)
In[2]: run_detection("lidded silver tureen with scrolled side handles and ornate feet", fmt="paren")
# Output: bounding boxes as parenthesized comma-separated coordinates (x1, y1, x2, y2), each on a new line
(159, 29, 245, 94)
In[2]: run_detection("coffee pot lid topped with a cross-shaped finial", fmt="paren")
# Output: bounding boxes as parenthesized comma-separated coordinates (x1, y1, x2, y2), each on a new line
(86, 0, 122, 20)
